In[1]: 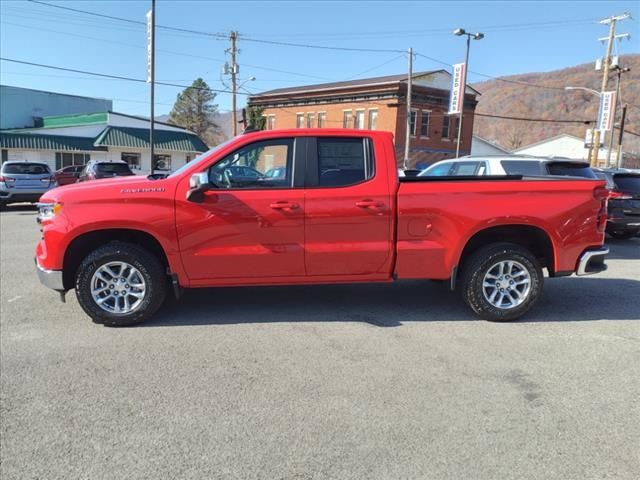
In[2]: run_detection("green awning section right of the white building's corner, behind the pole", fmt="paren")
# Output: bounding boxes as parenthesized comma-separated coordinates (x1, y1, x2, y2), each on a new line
(94, 127, 209, 152)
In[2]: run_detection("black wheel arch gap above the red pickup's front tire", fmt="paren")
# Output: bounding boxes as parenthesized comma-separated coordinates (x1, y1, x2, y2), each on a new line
(62, 228, 170, 290)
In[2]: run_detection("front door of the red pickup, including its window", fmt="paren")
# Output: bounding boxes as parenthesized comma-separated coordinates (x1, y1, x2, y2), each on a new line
(176, 138, 305, 284)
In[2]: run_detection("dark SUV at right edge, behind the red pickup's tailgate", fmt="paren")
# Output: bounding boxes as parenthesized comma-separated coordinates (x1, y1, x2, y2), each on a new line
(594, 168, 640, 239)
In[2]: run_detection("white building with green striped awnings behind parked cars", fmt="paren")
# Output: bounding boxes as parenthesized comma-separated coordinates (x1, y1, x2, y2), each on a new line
(0, 111, 208, 174)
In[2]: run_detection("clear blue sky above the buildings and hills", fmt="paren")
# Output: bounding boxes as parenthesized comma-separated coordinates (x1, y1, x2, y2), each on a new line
(0, 0, 640, 114)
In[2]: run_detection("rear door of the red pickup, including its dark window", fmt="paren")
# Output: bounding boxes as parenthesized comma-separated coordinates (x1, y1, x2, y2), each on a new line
(305, 136, 395, 279)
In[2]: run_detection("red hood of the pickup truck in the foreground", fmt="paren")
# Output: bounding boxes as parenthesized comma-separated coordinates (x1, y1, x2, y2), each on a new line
(40, 175, 173, 203)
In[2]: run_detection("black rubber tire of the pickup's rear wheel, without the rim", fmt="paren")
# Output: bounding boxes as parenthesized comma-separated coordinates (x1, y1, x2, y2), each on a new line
(461, 243, 544, 322)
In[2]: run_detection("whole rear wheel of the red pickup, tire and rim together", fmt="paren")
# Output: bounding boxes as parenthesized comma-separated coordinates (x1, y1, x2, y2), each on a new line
(461, 243, 544, 322)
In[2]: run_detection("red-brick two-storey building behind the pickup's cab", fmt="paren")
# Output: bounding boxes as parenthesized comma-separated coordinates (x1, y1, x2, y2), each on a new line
(248, 70, 479, 167)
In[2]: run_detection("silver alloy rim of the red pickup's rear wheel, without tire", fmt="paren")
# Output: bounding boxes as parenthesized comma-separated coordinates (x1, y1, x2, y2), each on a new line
(482, 260, 531, 310)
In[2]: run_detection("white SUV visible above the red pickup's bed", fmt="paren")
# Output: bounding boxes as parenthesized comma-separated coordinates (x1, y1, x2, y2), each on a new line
(419, 155, 596, 178)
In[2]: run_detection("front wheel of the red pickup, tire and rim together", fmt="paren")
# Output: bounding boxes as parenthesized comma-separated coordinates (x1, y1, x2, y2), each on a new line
(76, 242, 167, 327)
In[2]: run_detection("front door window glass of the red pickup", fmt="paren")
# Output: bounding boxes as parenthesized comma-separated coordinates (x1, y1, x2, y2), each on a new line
(209, 138, 293, 189)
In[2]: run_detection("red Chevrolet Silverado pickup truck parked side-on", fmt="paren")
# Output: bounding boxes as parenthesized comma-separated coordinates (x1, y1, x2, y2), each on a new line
(36, 129, 608, 326)
